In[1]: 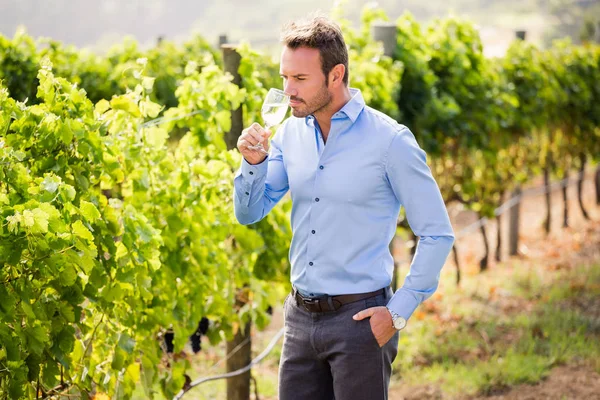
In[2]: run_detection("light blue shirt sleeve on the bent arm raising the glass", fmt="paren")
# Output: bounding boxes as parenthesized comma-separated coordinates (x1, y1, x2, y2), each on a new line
(233, 126, 289, 225)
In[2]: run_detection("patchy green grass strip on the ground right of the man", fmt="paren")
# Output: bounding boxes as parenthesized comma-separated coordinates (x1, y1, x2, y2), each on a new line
(394, 265, 600, 397)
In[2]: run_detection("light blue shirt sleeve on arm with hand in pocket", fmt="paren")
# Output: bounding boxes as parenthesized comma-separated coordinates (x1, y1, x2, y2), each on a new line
(385, 127, 454, 319)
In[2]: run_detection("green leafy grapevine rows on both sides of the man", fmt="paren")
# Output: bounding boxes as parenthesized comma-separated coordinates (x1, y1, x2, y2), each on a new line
(0, 3, 600, 399)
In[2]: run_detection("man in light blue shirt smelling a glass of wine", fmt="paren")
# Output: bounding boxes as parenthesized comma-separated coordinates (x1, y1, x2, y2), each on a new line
(234, 17, 454, 400)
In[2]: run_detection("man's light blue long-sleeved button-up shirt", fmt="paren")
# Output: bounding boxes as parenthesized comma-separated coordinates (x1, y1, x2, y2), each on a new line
(234, 89, 454, 319)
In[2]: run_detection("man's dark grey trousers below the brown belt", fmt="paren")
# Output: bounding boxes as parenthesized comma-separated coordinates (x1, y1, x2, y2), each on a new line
(279, 287, 399, 400)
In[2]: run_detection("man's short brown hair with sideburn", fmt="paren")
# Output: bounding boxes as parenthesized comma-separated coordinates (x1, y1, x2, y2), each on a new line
(281, 15, 348, 86)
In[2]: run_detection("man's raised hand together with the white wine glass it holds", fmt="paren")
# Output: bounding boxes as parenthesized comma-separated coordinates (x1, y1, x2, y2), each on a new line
(238, 88, 290, 164)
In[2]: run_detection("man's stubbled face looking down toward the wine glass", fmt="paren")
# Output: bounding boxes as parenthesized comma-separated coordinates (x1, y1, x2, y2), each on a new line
(279, 46, 332, 118)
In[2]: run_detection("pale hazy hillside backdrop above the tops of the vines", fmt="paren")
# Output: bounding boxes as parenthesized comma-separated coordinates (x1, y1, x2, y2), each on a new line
(0, 0, 600, 51)
